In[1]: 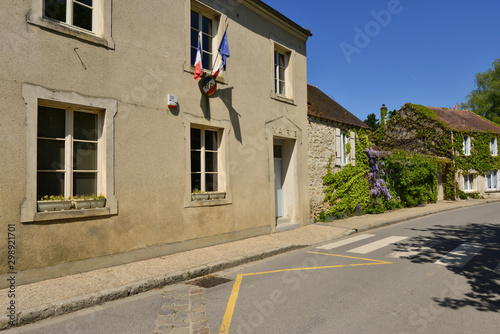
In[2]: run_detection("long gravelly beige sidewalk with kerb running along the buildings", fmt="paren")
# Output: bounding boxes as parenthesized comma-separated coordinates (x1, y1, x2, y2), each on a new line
(0, 199, 500, 330)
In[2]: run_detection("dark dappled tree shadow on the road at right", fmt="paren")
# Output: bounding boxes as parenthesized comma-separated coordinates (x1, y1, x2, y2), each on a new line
(395, 223, 500, 312)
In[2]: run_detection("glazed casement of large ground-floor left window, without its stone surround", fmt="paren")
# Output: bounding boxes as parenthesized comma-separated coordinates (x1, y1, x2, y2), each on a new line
(36, 104, 102, 199)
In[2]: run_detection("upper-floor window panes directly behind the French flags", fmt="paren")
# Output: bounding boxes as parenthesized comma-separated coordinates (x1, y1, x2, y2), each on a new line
(191, 10, 215, 71)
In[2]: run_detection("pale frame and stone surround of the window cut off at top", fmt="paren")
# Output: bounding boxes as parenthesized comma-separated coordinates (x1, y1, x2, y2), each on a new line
(27, 0, 115, 49)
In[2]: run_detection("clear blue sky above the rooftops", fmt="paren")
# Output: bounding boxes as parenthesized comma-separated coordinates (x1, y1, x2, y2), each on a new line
(263, 0, 500, 120)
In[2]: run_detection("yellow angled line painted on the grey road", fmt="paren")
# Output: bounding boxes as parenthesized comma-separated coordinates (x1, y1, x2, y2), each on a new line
(219, 252, 392, 334)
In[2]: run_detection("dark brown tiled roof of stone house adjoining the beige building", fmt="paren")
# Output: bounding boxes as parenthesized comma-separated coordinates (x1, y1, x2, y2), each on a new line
(307, 84, 370, 129)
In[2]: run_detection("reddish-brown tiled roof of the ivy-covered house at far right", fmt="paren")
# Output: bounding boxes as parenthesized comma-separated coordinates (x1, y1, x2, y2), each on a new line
(428, 107, 500, 134)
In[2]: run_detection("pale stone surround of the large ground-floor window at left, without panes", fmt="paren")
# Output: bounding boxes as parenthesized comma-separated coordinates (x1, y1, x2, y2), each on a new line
(21, 84, 118, 223)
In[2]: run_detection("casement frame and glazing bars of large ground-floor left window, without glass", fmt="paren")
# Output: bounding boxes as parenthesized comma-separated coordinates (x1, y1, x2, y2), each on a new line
(37, 100, 105, 198)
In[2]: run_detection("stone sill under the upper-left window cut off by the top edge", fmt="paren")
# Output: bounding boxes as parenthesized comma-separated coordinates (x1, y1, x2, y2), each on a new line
(28, 16, 115, 49)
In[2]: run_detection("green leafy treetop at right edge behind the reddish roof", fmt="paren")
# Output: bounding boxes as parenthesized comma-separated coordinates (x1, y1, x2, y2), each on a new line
(460, 58, 500, 124)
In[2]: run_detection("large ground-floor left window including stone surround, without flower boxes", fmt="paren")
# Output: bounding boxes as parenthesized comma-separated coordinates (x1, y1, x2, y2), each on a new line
(21, 84, 118, 222)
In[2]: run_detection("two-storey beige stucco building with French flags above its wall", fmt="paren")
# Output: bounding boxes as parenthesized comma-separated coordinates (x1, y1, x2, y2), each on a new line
(0, 0, 311, 287)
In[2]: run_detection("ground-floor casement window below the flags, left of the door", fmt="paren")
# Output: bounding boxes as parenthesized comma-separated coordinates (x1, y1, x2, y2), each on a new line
(191, 127, 221, 192)
